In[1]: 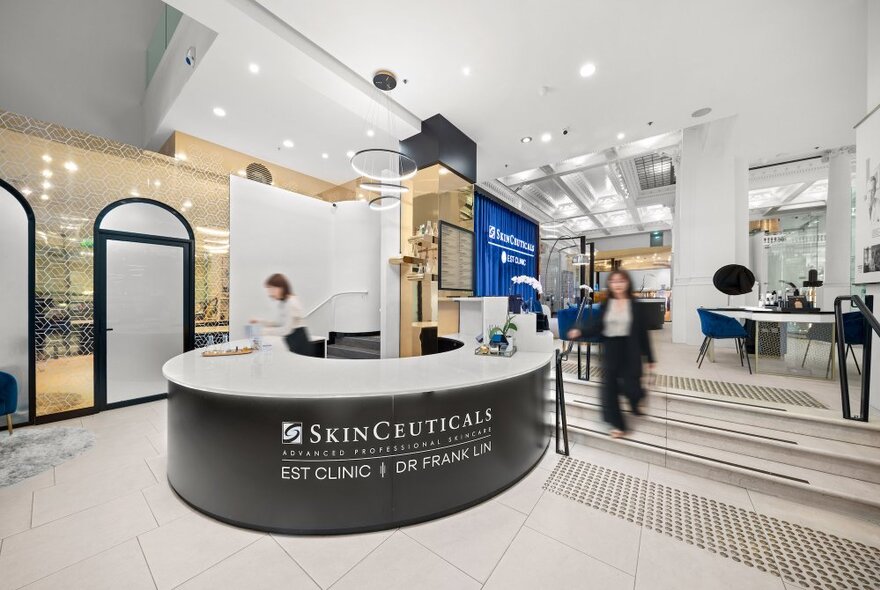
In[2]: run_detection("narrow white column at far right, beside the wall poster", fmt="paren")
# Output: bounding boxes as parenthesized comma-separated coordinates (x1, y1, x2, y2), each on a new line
(818, 148, 852, 311)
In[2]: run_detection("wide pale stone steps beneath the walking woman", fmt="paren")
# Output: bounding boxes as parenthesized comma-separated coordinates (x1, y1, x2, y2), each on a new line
(548, 375, 880, 523)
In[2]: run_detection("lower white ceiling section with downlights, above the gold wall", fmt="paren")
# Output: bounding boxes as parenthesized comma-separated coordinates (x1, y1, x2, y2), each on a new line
(162, 0, 419, 183)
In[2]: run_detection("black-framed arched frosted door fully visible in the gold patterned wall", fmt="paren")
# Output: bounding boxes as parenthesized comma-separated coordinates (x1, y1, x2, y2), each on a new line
(94, 198, 195, 410)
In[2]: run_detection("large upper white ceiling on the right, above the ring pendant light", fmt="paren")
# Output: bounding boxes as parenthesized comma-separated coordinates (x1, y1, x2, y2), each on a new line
(253, 0, 867, 180)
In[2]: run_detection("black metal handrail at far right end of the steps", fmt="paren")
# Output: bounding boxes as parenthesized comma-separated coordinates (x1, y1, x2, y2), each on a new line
(834, 295, 880, 422)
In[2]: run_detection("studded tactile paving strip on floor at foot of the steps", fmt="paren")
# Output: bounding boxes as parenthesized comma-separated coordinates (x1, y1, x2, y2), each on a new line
(544, 457, 880, 590)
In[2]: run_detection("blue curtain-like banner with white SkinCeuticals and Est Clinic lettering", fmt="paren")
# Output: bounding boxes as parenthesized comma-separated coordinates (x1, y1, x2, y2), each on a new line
(474, 193, 538, 301)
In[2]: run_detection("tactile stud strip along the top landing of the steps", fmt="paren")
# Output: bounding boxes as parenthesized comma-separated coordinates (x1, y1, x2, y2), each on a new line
(562, 361, 827, 409)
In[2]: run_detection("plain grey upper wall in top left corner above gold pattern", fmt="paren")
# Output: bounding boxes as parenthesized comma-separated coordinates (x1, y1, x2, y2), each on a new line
(0, 0, 162, 145)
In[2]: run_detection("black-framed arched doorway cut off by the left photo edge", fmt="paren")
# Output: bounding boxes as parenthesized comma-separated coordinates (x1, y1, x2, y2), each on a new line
(0, 179, 36, 424)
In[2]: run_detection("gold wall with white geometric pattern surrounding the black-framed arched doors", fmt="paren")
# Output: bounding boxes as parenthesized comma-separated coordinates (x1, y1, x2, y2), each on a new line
(0, 110, 230, 416)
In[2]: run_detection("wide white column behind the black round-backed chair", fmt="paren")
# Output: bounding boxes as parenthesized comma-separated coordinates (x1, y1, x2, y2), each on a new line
(672, 117, 750, 345)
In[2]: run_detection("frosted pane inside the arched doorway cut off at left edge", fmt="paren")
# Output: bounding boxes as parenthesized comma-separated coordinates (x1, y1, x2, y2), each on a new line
(0, 188, 29, 422)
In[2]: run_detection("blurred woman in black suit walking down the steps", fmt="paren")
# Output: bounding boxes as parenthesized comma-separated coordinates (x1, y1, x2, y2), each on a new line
(568, 270, 654, 438)
